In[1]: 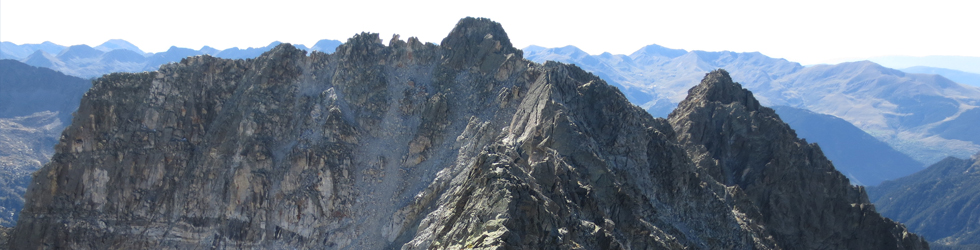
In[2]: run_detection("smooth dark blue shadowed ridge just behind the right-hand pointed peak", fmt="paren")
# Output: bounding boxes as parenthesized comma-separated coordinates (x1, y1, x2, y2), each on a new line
(773, 106, 925, 186)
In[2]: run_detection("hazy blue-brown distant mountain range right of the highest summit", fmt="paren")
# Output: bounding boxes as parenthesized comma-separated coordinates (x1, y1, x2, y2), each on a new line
(524, 45, 980, 166)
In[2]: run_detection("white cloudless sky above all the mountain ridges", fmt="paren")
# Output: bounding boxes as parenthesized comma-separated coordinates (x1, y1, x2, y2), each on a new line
(0, 0, 980, 64)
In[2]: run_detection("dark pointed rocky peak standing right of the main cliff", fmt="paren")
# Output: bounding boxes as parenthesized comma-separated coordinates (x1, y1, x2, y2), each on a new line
(669, 70, 926, 249)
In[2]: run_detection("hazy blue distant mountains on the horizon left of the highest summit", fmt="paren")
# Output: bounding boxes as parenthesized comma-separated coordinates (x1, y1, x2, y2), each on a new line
(0, 39, 341, 78)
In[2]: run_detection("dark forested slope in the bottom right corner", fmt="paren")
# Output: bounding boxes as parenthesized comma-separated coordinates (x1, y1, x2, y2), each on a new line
(868, 154, 980, 249)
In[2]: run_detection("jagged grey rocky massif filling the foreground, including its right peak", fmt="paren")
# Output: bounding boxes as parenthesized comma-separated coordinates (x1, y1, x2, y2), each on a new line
(11, 18, 926, 249)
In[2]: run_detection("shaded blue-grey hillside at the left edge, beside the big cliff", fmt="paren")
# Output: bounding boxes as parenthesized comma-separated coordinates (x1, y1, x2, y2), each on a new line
(0, 60, 91, 227)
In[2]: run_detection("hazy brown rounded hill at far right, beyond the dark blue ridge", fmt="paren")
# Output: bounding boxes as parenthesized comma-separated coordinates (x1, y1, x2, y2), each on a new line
(760, 61, 980, 163)
